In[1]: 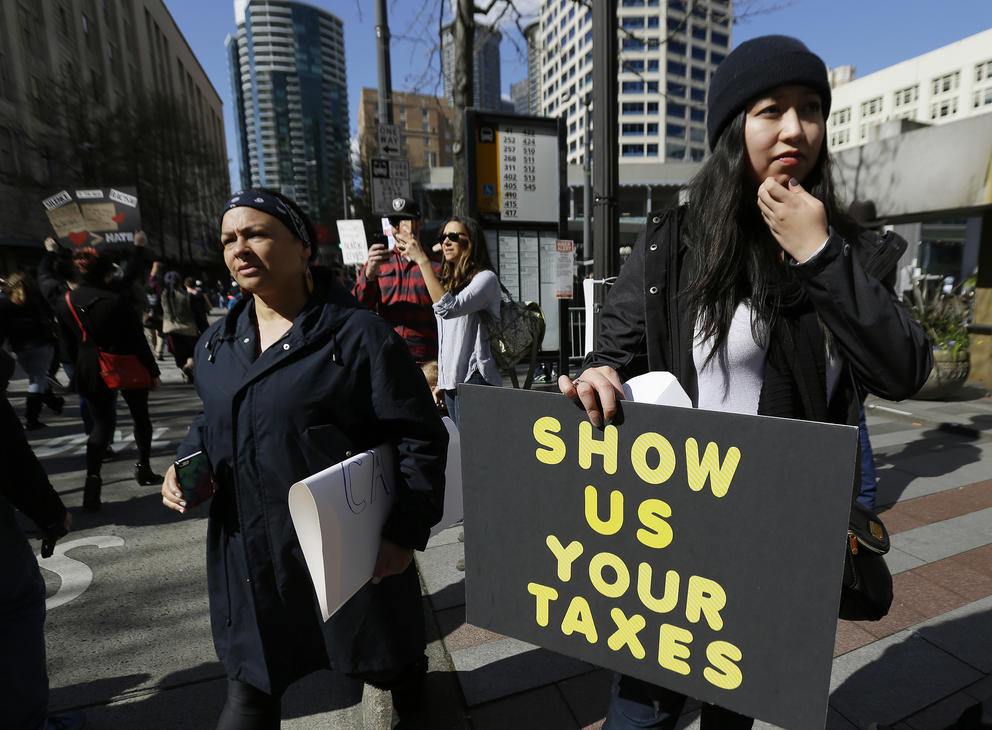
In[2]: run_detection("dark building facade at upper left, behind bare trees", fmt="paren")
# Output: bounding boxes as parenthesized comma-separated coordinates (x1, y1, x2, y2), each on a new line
(0, 0, 230, 267)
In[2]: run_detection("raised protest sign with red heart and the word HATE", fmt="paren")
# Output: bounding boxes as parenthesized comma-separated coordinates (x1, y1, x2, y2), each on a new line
(41, 187, 141, 248)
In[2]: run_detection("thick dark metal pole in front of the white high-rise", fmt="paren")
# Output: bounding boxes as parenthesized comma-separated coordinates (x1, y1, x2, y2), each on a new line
(592, 2, 620, 282)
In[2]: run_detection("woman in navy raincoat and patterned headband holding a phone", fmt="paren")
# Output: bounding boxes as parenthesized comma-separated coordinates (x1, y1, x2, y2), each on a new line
(162, 190, 448, 729)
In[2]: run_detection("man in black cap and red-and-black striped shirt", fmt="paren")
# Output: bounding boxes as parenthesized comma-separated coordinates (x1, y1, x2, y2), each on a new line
(353, 198, 440, 363)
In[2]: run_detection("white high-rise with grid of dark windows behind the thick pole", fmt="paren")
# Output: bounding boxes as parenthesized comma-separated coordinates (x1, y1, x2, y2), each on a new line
(538, 0, 731, 164)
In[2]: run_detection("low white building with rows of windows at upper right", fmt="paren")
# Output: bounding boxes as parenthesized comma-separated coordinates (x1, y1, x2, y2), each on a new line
(827, 29, 992, 151)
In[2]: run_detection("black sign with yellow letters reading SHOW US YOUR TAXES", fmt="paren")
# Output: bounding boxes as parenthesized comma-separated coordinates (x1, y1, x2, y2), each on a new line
(459, 385, 858, 728)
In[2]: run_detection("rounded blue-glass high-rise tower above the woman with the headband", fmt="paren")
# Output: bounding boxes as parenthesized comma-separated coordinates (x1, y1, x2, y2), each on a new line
(226, 0, 351, 226)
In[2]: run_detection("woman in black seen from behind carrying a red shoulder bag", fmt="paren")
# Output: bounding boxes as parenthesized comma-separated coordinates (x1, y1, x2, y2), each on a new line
(56, 247, 162, 511)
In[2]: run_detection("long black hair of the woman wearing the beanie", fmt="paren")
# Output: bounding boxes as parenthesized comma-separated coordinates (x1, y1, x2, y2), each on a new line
(681, 110, 857, 357)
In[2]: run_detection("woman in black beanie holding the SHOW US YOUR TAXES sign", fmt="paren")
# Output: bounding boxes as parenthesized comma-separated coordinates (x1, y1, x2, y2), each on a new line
(559, 36, 931, 730)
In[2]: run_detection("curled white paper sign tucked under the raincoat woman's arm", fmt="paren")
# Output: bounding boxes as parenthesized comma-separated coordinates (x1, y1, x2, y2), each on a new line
(289, 417, 462, 621)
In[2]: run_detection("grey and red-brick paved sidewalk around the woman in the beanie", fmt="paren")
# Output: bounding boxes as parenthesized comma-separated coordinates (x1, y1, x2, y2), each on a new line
(417, 378, 992, 730)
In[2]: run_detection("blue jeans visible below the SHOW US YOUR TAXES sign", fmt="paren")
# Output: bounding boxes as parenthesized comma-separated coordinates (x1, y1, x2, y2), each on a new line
(603, 674, 754, 730)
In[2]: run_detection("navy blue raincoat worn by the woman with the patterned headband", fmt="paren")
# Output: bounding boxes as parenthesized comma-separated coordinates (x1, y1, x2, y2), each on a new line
(178, 276, 448, 693)
